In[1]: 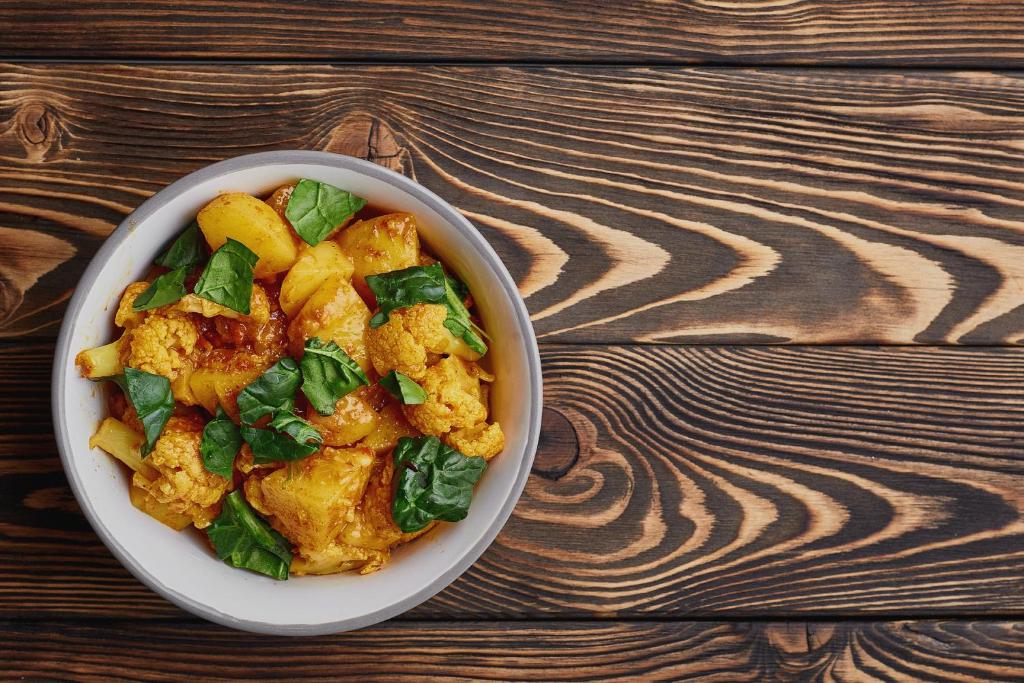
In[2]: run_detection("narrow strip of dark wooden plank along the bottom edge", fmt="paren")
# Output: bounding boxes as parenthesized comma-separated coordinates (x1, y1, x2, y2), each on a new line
(0, 621, 1024, 683)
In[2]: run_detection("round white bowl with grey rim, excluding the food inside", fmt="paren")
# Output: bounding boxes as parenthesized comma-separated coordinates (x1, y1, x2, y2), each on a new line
(52, 152, 541, 635)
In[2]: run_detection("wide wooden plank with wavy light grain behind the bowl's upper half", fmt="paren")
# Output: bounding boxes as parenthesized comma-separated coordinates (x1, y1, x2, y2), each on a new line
(0, 65, 1024, 344)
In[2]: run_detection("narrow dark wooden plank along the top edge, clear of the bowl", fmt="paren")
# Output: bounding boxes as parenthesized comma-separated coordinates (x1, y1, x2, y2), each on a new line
(0, 0, 1024, 67)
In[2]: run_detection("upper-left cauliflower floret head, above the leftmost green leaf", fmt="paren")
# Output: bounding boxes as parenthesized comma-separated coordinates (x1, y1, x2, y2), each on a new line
(121, 313, 199, 382)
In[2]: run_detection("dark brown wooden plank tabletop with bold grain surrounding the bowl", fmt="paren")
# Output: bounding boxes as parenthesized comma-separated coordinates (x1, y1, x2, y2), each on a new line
(6, 0, 1024, 681)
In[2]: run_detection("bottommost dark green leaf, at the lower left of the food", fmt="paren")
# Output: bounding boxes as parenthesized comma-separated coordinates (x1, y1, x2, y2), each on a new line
(206, 490, 292, 581)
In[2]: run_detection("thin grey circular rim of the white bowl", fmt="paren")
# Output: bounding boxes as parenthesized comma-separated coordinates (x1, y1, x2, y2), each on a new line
(50, 150, 543, 636)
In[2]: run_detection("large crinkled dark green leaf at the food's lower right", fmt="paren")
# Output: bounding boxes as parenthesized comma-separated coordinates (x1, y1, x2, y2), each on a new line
(391, 436, 487, 532)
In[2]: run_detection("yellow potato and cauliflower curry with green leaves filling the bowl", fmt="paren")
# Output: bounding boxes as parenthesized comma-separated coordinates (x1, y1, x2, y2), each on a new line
(76, 178, 505, 580)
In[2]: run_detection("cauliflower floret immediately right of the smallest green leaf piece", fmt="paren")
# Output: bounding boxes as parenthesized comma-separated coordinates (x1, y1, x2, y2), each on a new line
(404, 355, 487, 436)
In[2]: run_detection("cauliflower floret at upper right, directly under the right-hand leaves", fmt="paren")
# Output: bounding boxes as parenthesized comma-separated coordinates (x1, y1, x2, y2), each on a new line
(367, 303, 479, 380)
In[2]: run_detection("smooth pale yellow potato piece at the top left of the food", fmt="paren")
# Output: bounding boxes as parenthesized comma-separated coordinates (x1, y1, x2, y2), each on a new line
(196, 193, 299, 279)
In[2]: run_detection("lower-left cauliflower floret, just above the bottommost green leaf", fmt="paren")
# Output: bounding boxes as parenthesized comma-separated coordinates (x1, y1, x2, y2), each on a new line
(132, 416, 231, 528)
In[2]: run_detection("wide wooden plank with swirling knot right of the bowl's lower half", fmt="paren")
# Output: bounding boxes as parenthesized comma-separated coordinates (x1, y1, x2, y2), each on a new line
(8, 343, 1024, 620)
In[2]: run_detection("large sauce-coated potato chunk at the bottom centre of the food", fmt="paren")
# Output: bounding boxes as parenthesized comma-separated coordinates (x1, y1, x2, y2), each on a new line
(245, 447, 374, 553)
